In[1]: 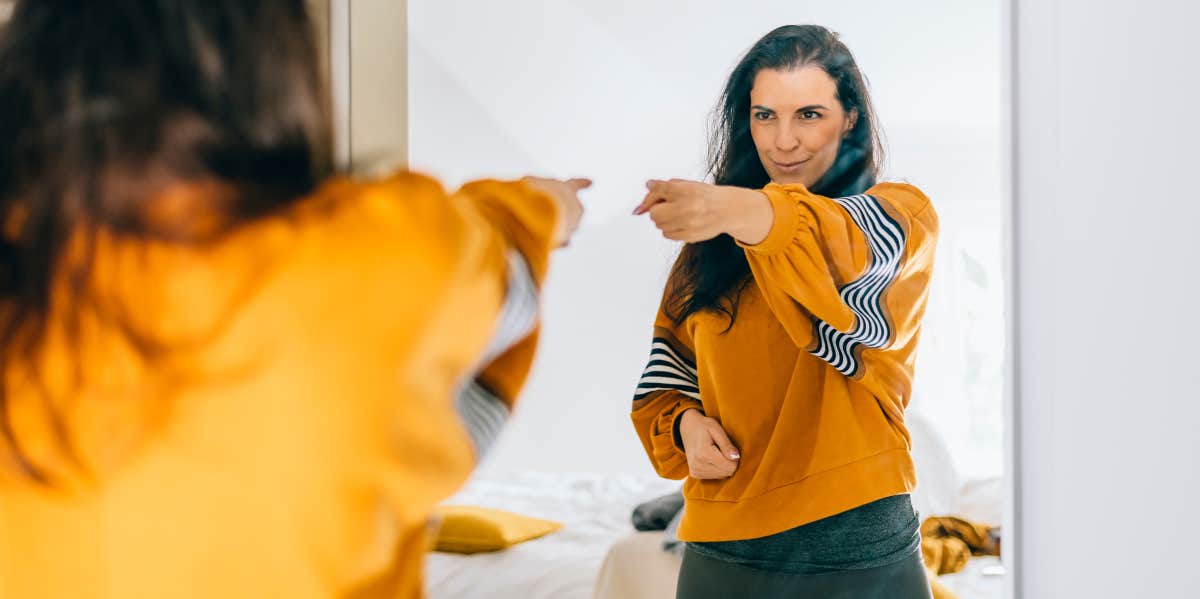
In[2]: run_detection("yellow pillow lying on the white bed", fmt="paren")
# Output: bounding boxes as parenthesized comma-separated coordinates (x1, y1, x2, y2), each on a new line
(433, 505, 563, 553)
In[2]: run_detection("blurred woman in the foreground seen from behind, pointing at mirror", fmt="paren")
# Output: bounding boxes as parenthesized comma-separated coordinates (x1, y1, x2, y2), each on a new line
(0, 0, 587, 598)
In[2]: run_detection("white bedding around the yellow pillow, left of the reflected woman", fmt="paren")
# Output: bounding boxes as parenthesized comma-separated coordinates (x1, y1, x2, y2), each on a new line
(425, 473, 680, 599)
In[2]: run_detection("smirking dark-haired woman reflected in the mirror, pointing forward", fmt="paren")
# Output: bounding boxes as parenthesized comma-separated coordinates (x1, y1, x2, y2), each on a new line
(632, 26, 937, 599)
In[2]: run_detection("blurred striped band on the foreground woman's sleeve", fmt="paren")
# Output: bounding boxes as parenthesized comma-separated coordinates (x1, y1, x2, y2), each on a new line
(455, 251, 538, 456)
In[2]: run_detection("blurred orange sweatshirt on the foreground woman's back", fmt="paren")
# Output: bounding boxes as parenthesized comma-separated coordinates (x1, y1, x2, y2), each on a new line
(0, 174, 558, 599)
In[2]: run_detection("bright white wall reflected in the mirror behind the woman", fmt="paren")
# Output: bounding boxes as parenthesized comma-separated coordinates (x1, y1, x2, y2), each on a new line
(409, 0, 1003, 474)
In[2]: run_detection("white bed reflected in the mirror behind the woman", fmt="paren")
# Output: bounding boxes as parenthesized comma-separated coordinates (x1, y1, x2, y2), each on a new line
(426, 421, 1003, 599)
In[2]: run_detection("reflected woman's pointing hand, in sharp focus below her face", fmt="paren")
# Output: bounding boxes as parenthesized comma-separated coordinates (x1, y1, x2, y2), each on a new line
(634, 179, 775, 245)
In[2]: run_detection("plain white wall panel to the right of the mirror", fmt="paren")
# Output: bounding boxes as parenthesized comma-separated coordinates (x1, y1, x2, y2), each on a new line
(1015, 0, 1200, 599)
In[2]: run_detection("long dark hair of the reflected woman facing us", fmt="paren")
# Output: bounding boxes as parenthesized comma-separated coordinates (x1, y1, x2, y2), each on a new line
(664, 25, 883, 331)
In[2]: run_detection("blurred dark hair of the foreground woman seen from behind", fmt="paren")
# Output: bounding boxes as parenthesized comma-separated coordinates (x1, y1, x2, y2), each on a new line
(0, 0, 331, 475)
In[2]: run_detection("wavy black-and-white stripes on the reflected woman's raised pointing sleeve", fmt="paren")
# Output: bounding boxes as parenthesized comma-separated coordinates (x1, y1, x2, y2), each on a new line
(811, 196, 905, 377)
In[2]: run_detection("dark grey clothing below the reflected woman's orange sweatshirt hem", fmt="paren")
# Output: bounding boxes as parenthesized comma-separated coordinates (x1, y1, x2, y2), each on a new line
(676, 495, 932, 599)
